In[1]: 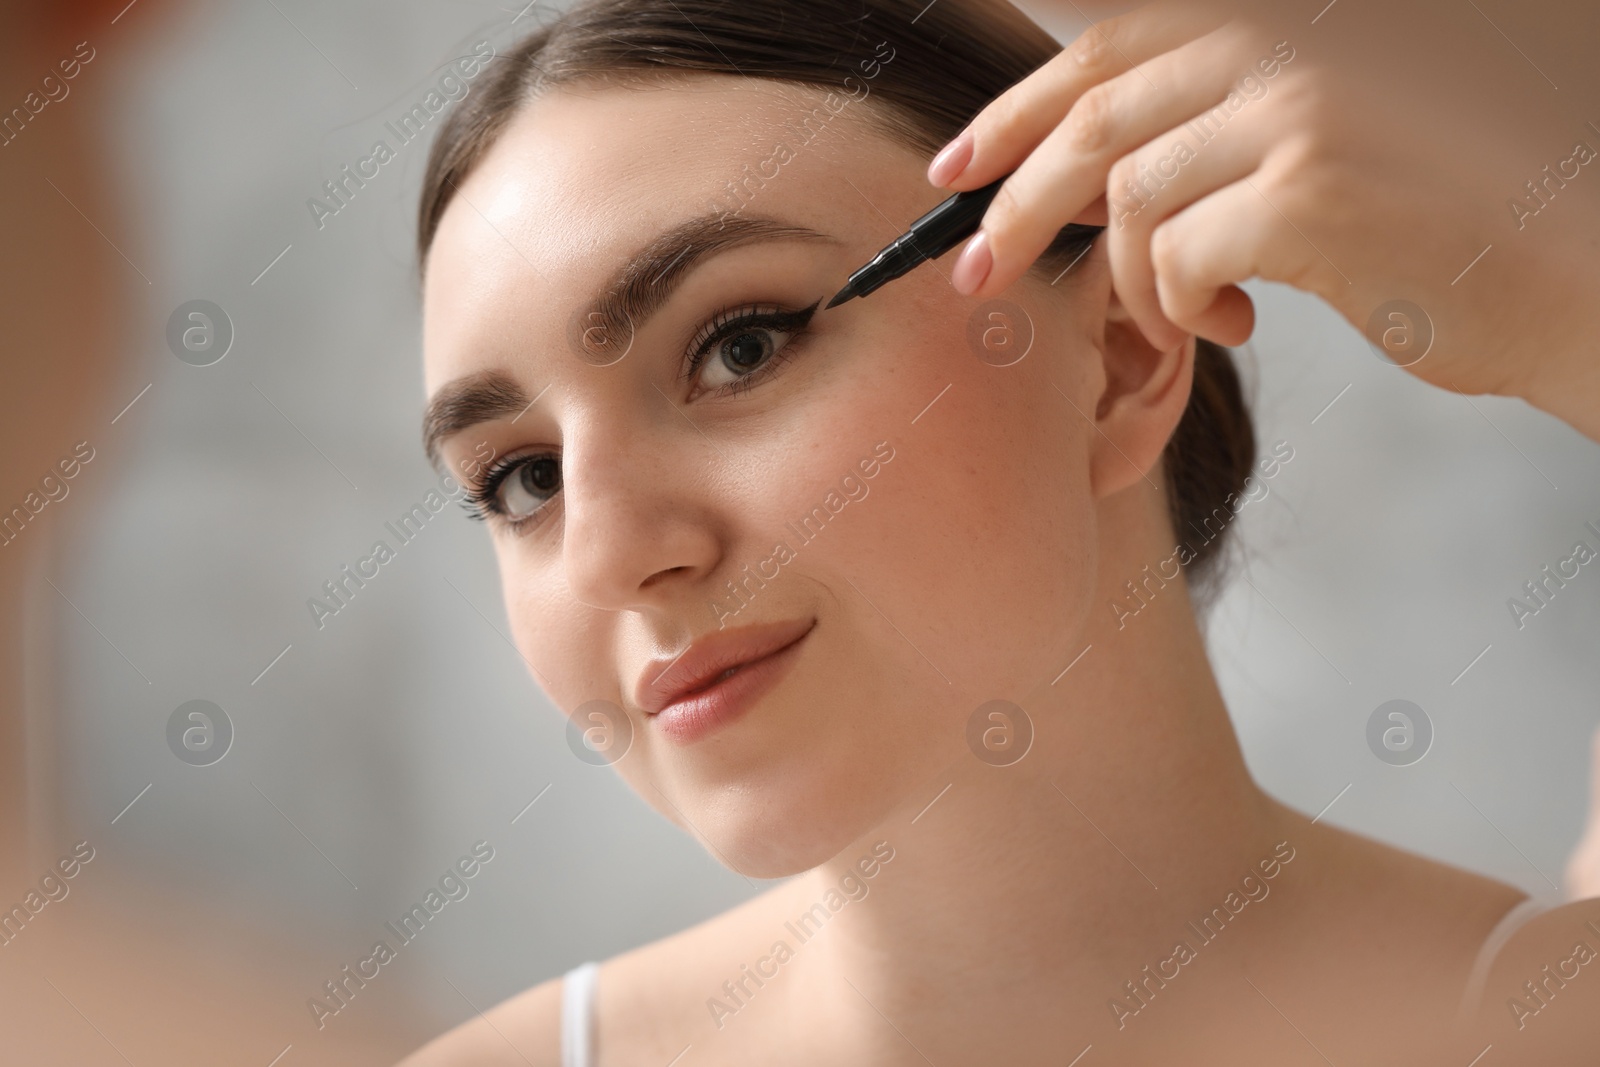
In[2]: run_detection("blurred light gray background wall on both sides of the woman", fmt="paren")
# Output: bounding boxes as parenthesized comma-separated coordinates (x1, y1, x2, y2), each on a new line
(34, 0, 1600, 1062)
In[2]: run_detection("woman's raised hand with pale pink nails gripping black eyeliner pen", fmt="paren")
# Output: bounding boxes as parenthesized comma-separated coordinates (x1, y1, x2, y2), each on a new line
(930, 0, 1600, 440)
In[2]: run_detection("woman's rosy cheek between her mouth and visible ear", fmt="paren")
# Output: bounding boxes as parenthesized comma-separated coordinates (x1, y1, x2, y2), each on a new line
(794, 300, 1096, 700)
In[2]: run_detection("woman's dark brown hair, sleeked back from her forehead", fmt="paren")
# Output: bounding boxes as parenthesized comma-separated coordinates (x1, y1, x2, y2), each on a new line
(418, 0, 1256, 598)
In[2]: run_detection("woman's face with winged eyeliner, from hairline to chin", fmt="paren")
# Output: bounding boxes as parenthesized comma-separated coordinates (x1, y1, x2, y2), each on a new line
(424, 77, 1104, 877)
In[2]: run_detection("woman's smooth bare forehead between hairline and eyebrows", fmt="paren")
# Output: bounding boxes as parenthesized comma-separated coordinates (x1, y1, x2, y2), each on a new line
(424, 75, 939, 392)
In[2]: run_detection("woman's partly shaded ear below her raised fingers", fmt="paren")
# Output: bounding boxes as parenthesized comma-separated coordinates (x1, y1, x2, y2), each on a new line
(1090, 273, 1195, 499)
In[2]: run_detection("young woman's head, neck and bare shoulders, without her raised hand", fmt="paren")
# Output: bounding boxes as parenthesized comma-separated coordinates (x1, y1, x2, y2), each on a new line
(396, 0, 1600, 1067)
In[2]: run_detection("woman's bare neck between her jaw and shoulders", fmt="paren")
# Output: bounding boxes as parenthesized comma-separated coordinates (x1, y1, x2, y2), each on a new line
(792, 527, 1294, 1059)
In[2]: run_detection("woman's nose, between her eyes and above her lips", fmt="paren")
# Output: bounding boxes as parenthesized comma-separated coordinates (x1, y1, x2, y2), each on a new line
(562, 419, 722, 611)
